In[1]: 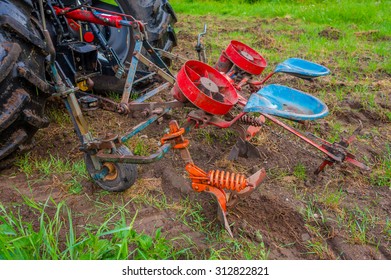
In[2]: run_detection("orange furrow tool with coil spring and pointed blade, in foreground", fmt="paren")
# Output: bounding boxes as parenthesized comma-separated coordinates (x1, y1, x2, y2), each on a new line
(160, 120, 266, 236)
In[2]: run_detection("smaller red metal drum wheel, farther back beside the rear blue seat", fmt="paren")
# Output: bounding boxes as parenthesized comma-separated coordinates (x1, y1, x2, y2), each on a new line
(225, 41, 267, 75)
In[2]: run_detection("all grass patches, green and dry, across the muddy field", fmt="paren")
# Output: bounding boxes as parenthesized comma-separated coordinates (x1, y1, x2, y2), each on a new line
(0, 0, 391, 259)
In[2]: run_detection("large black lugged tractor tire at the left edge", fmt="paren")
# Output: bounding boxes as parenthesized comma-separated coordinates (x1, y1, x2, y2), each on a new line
(0, 0, 49, 165)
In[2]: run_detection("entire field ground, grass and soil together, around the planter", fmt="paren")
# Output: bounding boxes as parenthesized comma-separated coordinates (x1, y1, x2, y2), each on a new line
(0, 0, 391, 259)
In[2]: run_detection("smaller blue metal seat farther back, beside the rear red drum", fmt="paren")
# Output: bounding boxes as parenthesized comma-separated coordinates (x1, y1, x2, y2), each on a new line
(274, 58, 330, 79)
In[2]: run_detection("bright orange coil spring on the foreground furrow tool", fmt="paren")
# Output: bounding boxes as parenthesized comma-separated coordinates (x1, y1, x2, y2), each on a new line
(208, 170, 248, 192)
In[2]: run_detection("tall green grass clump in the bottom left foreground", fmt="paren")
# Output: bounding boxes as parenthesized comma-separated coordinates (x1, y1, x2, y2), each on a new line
(0, 198, 183, 260)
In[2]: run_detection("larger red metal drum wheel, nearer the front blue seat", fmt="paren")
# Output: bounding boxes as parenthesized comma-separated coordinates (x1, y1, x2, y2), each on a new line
(172, 60, 238, 115)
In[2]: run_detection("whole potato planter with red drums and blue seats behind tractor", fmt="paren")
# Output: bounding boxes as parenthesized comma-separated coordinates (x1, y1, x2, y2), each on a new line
(34, 2, 369, 236)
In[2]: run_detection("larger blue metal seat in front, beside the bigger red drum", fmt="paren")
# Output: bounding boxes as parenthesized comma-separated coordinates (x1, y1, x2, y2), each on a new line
(244, 85, 329, 121)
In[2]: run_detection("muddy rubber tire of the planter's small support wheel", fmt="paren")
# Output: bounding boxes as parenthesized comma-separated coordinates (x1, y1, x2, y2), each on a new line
(84, 146, 137, 192)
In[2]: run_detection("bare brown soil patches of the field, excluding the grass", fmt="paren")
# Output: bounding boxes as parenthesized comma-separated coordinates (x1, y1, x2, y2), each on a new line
(0, 16, 391, 259)
